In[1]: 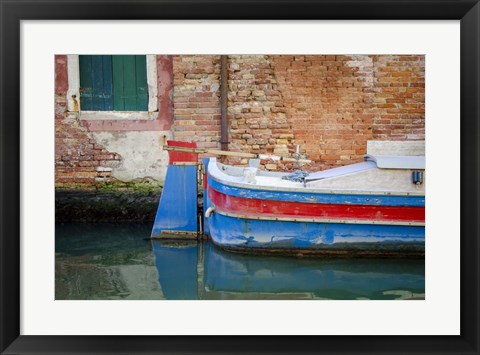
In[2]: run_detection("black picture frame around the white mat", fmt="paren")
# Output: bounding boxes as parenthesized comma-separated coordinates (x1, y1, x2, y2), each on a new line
(0, 0, 480, 354)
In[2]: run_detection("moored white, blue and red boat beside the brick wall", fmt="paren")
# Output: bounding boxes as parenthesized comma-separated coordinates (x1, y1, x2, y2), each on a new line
(206, 145, 425, 257)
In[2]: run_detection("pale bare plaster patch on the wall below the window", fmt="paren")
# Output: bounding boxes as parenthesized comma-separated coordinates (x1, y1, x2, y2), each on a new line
(92, 131, 171, 183)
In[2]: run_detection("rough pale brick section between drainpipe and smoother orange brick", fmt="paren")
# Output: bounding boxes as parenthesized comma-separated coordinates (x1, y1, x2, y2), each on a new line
(228, 56, 293, 168)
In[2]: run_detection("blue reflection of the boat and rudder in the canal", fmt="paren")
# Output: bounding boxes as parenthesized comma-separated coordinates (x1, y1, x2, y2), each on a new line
(152, 240, 425, 300)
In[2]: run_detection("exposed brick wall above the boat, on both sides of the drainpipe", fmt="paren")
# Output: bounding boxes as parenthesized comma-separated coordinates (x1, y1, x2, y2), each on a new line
(174, 55, 425, 170)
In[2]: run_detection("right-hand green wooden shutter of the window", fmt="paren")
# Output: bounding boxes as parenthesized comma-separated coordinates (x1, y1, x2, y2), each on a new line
(112, 55, 148, 111)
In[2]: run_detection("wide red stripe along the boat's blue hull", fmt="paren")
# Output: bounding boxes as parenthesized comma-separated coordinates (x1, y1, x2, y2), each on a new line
(208, 186, 425, 222)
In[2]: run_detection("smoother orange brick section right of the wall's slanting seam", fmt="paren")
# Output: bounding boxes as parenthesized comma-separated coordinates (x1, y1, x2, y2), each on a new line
(272, 55, 425, 168)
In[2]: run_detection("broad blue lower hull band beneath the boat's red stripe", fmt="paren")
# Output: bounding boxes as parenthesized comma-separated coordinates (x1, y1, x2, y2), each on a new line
(208, 213, 425, 256)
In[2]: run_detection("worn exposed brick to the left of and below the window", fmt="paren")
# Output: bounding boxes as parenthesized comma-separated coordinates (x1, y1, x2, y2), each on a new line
(55, 55, 121, 186)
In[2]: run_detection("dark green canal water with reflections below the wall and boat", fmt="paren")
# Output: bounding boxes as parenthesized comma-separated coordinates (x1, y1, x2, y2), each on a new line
(55, 224, 425, 300)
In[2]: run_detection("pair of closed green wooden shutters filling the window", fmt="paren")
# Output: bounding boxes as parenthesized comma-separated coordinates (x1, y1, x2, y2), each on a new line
(79, 55, 148, 111)
